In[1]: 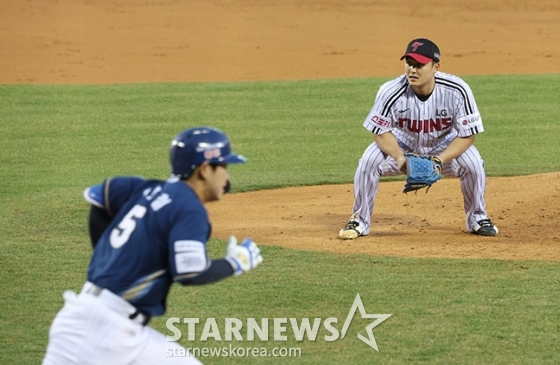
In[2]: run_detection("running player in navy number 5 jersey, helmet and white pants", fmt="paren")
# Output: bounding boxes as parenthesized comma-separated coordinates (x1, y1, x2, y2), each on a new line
(43, 127, 262, 365)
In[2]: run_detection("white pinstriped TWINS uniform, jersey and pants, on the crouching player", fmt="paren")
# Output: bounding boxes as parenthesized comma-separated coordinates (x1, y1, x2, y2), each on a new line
(350, 72, 488, 235)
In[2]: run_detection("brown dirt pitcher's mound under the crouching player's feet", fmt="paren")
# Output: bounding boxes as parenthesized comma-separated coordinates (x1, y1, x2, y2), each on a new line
(209, 173, 560, 260)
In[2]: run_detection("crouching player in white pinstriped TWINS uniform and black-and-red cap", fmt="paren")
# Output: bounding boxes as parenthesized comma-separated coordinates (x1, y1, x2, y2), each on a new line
(339, 38, 498, 239)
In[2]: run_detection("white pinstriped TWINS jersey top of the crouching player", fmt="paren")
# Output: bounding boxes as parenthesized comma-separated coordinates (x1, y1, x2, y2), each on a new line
(364, 72, 484, 154)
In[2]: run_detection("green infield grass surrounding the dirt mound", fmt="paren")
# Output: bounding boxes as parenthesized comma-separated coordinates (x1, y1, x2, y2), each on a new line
(0, 75, 560, 364)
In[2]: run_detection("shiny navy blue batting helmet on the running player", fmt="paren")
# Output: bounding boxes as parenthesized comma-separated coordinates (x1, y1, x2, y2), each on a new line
(169, 127, 247, 179)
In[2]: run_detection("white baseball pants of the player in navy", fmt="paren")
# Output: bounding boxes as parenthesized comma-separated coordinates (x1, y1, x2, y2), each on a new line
(43, 283, 202, 365)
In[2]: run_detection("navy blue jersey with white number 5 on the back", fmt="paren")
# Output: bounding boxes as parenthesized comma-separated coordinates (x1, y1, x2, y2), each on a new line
(86, 177, 211, 316)
